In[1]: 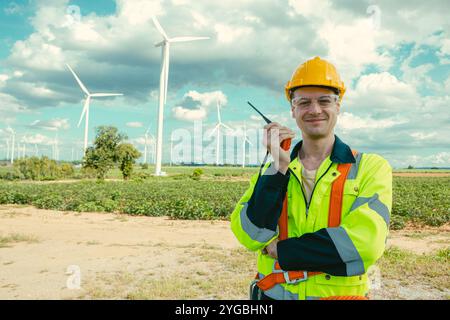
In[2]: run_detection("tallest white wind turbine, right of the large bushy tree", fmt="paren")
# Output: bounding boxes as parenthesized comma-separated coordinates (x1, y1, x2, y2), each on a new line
(152, 17, 209, 176)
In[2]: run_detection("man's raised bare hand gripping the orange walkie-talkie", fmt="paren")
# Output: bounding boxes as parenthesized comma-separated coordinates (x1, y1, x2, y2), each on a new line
(263, 122, 295, 174)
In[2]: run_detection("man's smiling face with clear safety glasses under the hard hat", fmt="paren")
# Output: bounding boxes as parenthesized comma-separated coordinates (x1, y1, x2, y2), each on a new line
(291, 87, 340, 139)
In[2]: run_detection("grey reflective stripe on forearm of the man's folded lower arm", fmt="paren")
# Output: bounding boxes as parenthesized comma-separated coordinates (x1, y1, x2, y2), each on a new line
(326, 227, 364, 276)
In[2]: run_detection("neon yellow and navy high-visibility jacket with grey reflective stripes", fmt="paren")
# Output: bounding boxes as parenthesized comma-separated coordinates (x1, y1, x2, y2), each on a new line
(231, 136, 392, 300)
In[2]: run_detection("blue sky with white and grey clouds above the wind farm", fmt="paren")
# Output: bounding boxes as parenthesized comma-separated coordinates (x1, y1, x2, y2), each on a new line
(0, 0, 450, 167)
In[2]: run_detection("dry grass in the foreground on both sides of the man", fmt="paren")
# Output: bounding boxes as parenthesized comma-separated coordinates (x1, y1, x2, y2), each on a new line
(75, 244, 450, 300)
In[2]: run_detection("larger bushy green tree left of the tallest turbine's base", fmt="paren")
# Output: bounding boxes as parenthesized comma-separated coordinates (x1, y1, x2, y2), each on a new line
(83, 126, 127, 179)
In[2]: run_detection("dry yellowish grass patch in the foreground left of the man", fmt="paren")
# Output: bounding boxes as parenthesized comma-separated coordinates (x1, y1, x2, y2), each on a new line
(79, 244, 255, 300)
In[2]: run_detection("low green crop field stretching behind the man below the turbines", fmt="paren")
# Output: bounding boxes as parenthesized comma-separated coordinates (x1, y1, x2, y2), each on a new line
(0, 167, 450, 229)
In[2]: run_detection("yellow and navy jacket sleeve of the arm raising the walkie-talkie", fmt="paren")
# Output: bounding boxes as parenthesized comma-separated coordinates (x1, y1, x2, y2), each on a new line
(231, 166, 289, 251)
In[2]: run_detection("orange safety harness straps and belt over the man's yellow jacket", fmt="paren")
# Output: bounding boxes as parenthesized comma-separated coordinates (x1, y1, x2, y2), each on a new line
(256, 150, 368, 300)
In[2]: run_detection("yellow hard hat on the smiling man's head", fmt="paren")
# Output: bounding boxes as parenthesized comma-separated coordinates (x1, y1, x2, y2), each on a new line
(285, 57, 345, 101)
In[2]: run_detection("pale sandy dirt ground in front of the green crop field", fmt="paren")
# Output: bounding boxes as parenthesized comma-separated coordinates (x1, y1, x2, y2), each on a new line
(0, 205, 449, 299)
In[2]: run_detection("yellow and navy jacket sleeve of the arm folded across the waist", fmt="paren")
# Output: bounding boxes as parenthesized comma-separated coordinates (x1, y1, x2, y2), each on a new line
(277, 155, 392, 276)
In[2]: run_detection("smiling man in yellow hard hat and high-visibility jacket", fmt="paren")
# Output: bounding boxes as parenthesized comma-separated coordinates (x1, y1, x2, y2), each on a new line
(231, 57, 392, 300)
